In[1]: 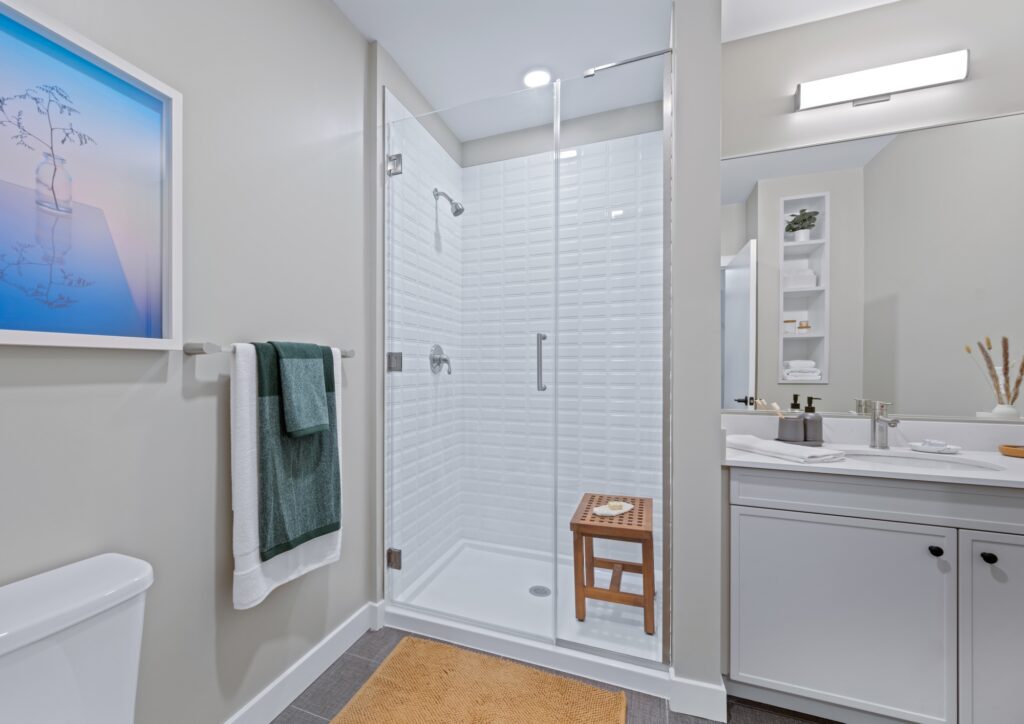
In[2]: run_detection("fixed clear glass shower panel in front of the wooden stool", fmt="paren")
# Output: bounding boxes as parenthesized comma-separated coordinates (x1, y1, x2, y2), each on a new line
(555, 55, 670, 662)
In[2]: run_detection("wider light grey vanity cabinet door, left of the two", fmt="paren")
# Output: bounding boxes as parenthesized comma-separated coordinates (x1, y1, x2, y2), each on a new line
(730, 506, 956, 722)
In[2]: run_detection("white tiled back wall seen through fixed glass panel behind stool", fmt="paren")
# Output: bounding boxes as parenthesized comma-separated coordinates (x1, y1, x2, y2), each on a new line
(557, 131, 665, 570)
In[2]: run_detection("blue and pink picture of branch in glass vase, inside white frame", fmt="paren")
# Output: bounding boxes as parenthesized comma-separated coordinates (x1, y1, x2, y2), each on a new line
(0, 14, 165, 339)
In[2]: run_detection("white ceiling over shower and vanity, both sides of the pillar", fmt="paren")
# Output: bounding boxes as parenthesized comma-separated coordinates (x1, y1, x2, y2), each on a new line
(335, 0, 894, 140)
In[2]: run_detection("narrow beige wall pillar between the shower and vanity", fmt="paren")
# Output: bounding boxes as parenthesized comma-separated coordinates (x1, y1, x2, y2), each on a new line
(671, 0, 725, 721)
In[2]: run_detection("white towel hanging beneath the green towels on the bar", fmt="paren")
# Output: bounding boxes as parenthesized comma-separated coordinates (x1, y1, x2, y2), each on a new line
(231, 344, 342, 608)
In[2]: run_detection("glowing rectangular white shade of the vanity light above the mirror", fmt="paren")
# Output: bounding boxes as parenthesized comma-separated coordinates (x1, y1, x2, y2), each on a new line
(797, 49, 970, 111)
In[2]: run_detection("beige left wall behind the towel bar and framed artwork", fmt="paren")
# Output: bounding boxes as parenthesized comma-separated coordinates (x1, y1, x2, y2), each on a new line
(0, 0, 374, 724)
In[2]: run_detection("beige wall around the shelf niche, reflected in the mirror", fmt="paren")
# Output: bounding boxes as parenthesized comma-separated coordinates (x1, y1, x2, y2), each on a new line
(757, 168, 864, 412)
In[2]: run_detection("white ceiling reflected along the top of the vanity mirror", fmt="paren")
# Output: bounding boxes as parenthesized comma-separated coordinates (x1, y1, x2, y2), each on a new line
(722, 135, 896, 204)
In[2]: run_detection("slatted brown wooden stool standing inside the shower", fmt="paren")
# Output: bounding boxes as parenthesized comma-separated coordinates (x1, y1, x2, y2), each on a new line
(569, 493, 654, 634)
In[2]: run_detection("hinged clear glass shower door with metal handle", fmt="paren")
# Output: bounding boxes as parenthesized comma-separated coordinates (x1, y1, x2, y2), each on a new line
(384, 81, 556, 640)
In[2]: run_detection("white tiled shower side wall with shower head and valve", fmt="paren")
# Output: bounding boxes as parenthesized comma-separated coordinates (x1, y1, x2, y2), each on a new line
(385, 93, 465, 598)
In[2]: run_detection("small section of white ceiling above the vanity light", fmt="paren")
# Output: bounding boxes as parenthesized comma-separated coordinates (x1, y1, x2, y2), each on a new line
(722, 0, 897, 43)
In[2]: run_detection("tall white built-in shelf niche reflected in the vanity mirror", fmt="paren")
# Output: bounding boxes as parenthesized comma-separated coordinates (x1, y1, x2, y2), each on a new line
(778, 193, 829, 385)
